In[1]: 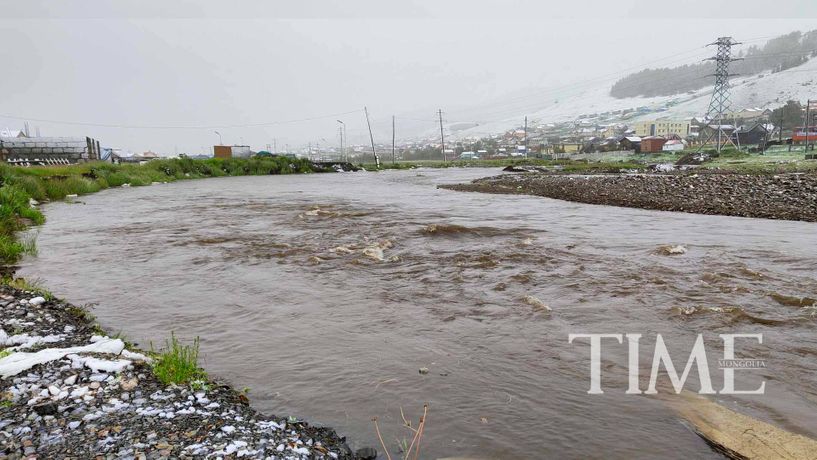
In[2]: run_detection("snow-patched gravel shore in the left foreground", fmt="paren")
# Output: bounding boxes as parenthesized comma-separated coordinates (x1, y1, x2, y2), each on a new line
(0, 286, 364, 459)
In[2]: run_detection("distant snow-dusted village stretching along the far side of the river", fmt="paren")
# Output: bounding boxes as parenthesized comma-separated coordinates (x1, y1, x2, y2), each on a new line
(0, 101, 817, 166)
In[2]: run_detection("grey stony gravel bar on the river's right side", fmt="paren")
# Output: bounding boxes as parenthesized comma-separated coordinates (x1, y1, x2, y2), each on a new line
(440, 172, 817, 222)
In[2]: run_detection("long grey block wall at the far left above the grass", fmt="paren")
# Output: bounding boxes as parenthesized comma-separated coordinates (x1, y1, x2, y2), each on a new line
(0, 137, 102, 164)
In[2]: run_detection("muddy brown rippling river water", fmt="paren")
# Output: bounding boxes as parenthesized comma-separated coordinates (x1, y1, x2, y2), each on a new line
(15, 169, 817, 459)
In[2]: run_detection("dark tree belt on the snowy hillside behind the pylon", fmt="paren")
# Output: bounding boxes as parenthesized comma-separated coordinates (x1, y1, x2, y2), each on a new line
(610, 30, 817, 98)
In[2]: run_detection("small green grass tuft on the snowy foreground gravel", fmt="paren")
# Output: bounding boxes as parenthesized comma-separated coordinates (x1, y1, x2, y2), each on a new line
(151, 333, 207, 385)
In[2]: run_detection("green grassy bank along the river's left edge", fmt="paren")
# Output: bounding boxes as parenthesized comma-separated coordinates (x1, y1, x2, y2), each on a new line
(0, 157, 316, 266)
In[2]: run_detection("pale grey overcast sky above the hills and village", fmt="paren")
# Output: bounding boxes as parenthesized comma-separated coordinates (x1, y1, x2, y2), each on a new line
(0, 0, 817, 154)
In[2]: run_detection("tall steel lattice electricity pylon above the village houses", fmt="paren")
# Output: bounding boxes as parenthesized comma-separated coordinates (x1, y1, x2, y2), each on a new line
(698, 37, 742, 154)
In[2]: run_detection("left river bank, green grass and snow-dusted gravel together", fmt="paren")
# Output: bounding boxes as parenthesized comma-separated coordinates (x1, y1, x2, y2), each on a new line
(0, 157, 380, 459)
